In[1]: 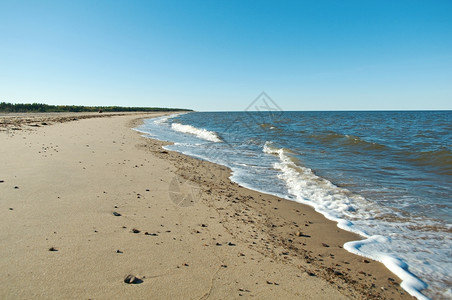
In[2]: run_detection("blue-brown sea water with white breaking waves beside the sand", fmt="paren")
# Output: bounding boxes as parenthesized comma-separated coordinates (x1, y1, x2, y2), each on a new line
(137, 111, 452, 299)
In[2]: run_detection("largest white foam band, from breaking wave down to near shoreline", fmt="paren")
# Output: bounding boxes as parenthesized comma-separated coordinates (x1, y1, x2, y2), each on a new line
(263, 142, 428, 299)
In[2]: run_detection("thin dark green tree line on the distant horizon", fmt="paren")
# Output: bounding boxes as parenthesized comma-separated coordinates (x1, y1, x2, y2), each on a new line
(0, 102, 191, 112)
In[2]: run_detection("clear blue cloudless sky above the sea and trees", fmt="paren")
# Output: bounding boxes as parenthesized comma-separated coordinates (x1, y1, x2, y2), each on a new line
(0, 0, 452, 111)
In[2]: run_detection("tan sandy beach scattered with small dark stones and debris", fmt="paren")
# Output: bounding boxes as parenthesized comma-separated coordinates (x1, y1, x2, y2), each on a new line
(0, 112, 412, 299)
